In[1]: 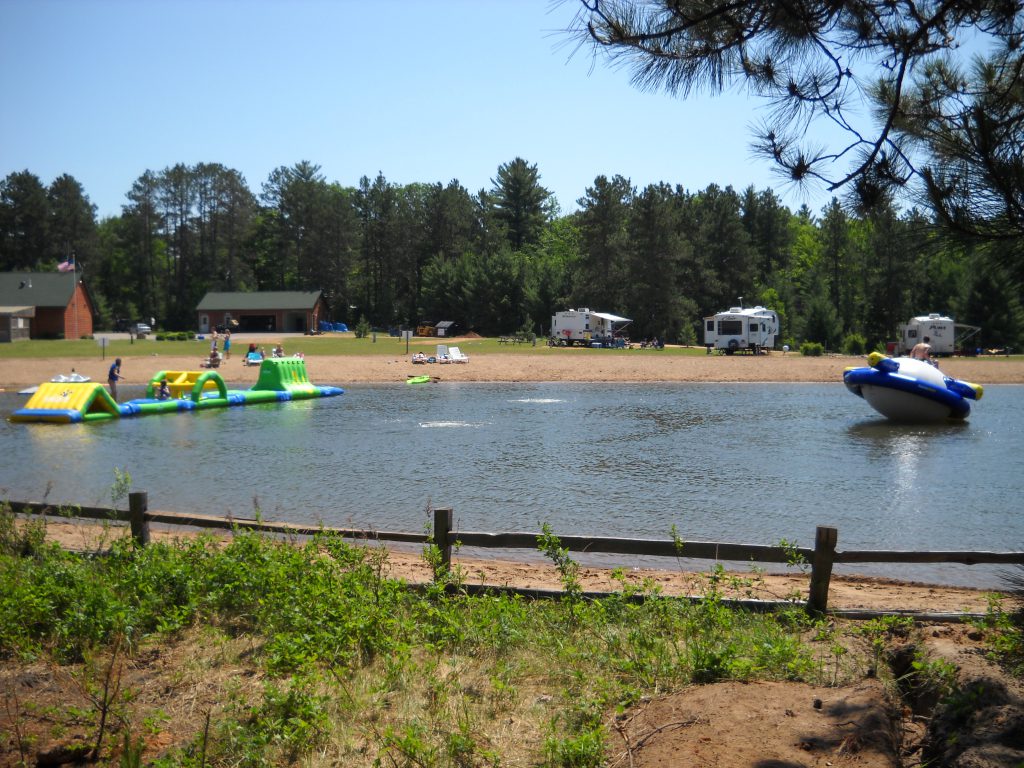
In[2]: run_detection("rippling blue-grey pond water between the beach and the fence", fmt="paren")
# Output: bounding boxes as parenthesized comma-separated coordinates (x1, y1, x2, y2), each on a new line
(0, 383, 1024, 587)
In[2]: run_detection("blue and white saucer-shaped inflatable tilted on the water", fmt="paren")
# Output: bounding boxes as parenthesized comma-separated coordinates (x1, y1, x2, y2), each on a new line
(843, 352, 984, 422)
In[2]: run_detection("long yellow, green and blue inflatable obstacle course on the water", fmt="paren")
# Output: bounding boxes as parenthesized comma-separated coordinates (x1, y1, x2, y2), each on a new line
(10, 357, 345, 424)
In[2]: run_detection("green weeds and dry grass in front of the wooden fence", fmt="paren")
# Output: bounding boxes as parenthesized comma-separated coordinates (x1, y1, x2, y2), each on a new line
(0, 516, 846, 768)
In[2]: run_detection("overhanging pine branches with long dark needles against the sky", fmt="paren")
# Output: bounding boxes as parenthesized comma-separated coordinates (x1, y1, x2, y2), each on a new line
(573, 0, 1024, 250)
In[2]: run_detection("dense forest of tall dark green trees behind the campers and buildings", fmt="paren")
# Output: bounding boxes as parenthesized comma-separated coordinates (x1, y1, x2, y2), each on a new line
(0, 157, 1024, 351)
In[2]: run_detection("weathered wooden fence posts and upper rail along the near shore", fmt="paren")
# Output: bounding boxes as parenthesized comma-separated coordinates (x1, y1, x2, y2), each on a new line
(6, 492, 1024, 613)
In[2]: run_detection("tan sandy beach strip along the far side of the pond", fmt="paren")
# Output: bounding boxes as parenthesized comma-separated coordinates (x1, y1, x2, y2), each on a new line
(0, 340, 1024, 389)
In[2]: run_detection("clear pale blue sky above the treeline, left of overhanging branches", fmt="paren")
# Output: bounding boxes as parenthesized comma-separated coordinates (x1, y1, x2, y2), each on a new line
(0, 0, 828, 216)
